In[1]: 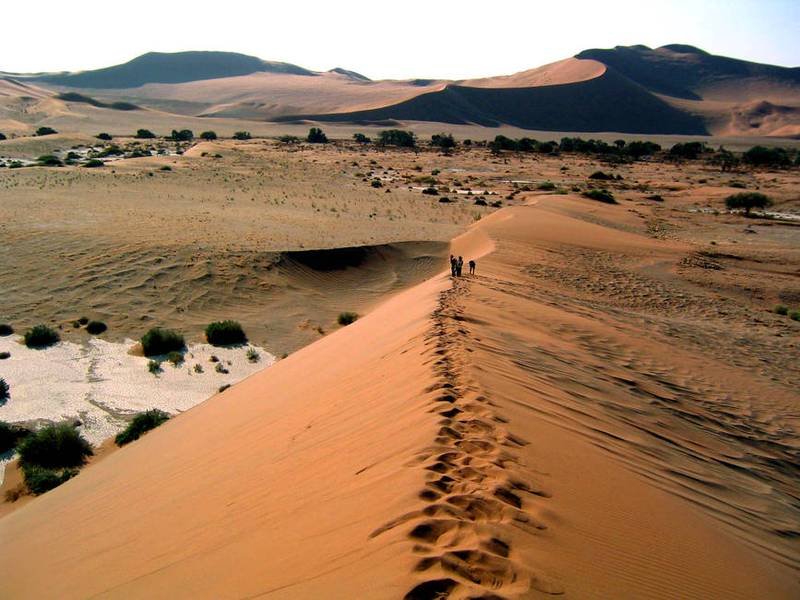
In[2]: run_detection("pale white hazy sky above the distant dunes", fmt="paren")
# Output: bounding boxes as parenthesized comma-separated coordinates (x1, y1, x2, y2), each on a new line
(0, 0, 800, 79)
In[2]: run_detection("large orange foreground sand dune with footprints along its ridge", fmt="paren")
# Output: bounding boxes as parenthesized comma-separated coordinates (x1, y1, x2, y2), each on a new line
(0, 196, 800, 600)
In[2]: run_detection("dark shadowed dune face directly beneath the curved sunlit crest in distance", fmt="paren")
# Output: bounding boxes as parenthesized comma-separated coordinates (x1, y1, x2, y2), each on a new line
(280, 70, 707, 134)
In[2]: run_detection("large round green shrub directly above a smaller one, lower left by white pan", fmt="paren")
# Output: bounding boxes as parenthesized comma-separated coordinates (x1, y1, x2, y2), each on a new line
(17, 423, 94, 469)
